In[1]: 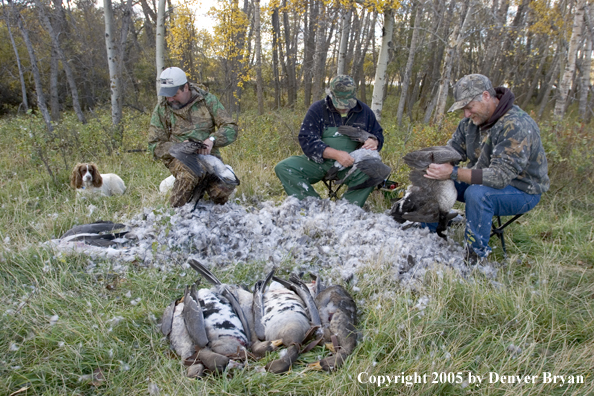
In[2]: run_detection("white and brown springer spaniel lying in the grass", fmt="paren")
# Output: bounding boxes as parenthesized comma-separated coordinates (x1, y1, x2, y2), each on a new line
(70, 162, 126, 197)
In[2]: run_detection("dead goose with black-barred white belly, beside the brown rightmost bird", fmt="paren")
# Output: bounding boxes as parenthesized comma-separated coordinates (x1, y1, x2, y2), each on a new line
(253, 270, 315, 373)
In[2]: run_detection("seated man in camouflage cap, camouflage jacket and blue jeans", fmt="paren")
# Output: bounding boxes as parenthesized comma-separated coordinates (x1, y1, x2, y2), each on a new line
(426, 74, 549, 264)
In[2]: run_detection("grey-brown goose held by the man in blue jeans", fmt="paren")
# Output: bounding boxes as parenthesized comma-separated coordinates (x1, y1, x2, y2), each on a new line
(390, 146, 462, 239)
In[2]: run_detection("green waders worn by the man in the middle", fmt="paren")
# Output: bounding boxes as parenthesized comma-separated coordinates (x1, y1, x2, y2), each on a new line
(274, 127, 374, 206)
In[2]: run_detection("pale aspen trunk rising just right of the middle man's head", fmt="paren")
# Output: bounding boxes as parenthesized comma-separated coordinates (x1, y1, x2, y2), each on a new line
(371, 8, 394, 122)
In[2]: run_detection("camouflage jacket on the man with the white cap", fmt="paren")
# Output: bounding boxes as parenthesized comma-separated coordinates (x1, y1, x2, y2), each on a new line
(148, 84, 237, 166)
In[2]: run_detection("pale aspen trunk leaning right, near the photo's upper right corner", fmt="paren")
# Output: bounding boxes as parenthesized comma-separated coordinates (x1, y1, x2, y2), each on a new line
(553, 0, 586, 120)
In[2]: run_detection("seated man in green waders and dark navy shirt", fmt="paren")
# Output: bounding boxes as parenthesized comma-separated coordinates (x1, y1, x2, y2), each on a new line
(274, 75, 384, 206)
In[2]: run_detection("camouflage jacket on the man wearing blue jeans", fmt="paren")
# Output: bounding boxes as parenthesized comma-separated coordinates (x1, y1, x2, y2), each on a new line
(448, 105, 549, 194)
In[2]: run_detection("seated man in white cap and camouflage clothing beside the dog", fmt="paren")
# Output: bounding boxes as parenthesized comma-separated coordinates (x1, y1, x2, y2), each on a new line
(148, 67, 237, 207)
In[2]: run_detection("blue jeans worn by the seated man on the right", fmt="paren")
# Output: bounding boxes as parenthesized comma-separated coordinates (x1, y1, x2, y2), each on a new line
(423, 182, 540, 257)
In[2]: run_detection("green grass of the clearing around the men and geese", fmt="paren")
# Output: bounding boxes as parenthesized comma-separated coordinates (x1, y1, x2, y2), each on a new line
(0, 111, 594, 395)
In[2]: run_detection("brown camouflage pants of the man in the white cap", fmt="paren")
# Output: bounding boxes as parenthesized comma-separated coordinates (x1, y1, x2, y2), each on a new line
(168, 158, 235, 208)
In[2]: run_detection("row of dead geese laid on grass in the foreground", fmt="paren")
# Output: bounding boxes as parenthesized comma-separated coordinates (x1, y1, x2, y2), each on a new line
(161, 259, 357, 377)
